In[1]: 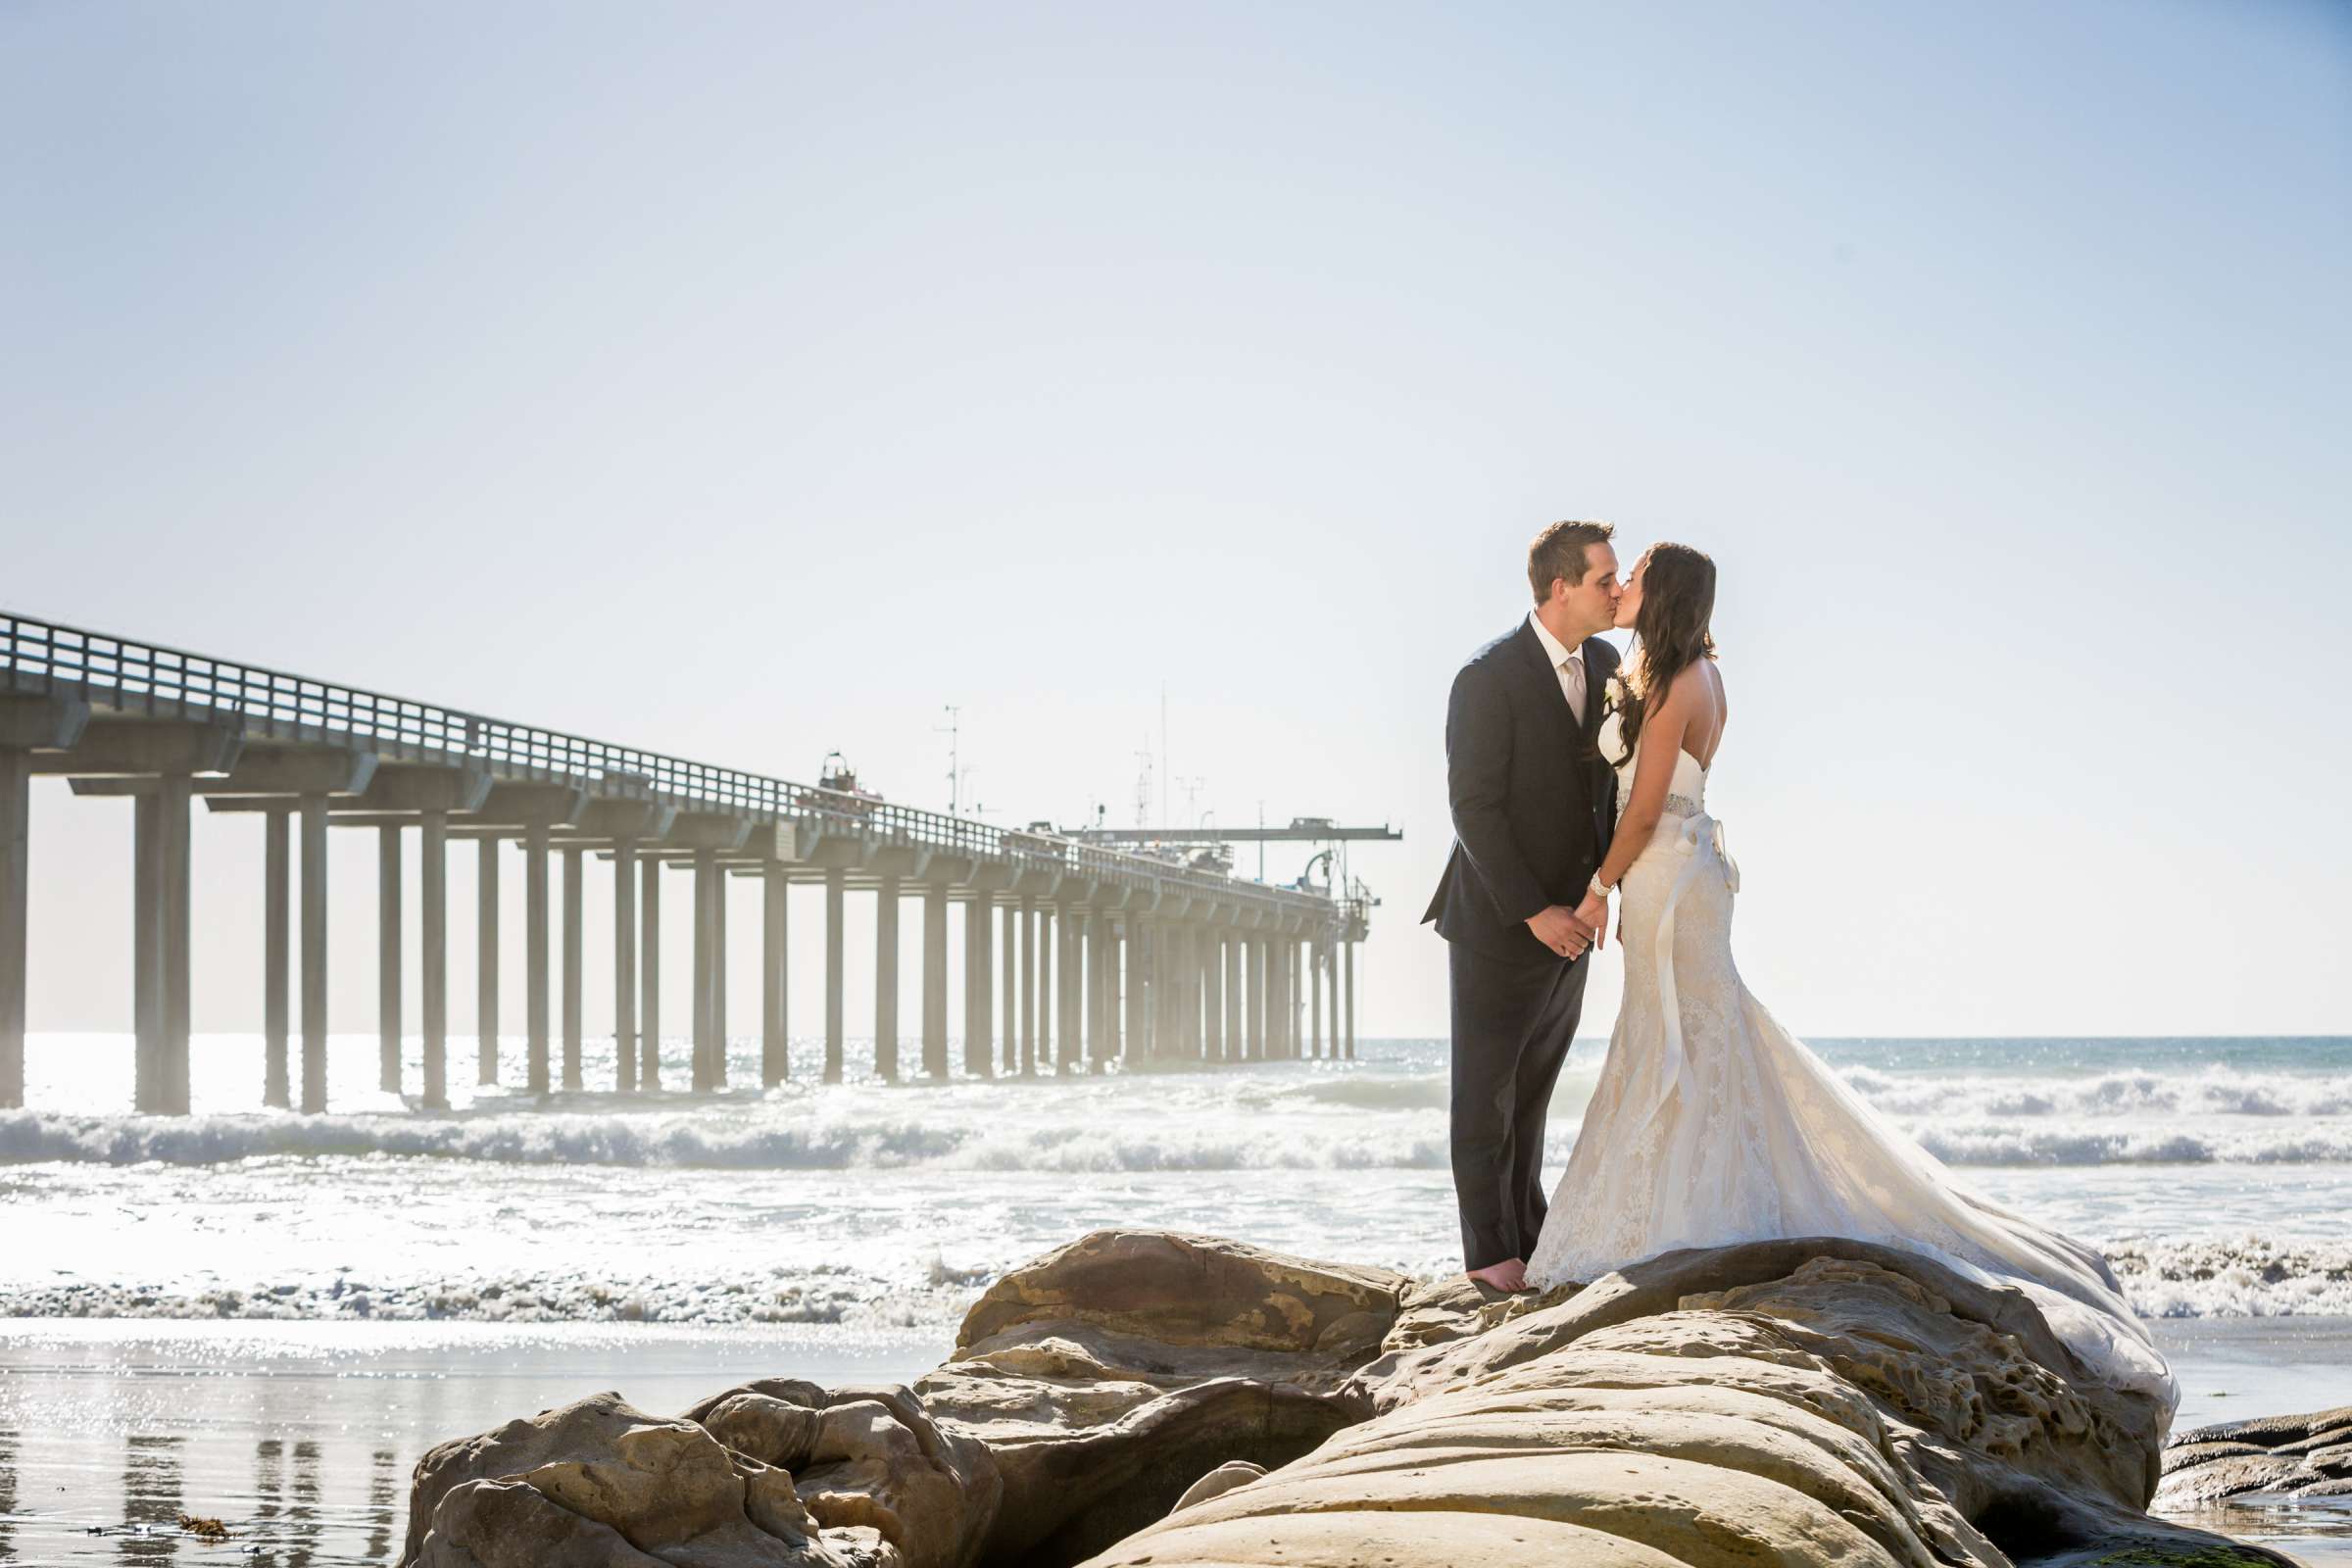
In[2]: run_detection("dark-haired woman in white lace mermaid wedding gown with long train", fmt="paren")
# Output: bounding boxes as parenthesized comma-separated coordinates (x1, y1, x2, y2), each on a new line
(1527, 543, 2178, 1405)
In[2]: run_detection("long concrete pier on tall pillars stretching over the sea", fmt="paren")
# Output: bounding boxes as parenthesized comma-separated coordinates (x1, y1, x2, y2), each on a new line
(0, 613, 1369, 1114)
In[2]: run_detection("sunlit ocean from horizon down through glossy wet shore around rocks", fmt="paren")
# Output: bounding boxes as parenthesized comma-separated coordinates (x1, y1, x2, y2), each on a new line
(0, 1034, 2352, 1563)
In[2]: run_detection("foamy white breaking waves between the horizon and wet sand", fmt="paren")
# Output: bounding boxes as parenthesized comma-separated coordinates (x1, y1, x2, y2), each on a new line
(0, 1037, 2352, 1333)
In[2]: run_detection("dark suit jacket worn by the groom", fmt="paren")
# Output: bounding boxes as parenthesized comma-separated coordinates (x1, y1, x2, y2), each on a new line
(1421, 620, 1618, 961)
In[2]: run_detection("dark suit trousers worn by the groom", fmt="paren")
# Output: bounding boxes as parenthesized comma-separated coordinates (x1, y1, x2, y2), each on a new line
(1446, 943, 1592, 1269)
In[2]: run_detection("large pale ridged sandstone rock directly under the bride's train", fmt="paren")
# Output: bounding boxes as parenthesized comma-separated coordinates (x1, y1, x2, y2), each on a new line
(1094, 1242, 2283, 1568)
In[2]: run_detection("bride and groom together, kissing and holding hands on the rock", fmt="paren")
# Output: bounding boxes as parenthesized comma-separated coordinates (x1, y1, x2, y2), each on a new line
(1423, 522, 2178, 1408)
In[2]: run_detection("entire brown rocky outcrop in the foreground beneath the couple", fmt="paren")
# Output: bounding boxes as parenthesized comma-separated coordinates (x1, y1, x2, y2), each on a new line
(407, 1232, 2295, 1568)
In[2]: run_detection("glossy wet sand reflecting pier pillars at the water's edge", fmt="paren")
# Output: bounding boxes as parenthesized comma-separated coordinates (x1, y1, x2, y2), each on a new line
(0, 1319, 2352, 1568)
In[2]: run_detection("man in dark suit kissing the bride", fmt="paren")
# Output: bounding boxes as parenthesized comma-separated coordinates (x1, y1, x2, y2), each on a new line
(1421, 522, 1621, 1291)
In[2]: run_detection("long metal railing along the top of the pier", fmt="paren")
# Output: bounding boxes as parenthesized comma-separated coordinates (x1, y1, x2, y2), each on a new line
(0, 612, 1331, 912)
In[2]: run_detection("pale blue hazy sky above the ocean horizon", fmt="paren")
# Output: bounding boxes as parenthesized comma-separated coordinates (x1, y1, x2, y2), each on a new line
(0, 0, 2352, 1034)
